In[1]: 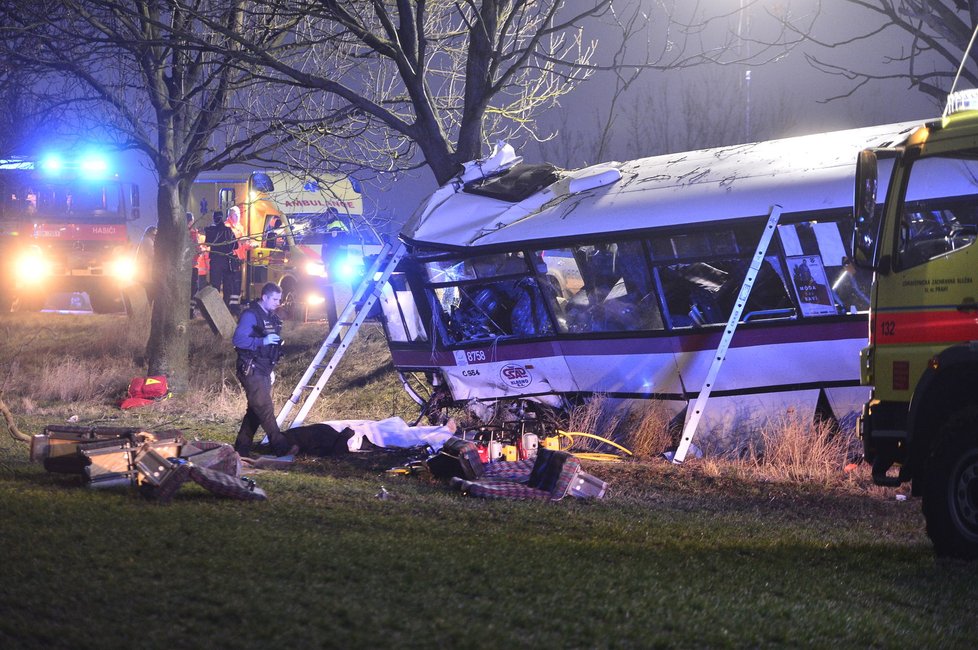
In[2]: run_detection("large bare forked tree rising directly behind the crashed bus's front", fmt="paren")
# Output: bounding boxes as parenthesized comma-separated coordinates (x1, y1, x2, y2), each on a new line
(194, 0, 772, 183)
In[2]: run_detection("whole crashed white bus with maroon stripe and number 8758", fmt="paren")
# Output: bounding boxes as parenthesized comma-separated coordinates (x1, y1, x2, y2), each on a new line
(374, 124, 912, 451)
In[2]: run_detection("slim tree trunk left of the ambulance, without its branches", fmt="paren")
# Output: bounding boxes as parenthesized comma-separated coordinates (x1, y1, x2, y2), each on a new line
(146, 179, 191, 392)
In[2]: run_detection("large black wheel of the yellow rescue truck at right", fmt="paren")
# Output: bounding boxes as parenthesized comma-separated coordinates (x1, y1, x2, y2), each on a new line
(923, 408, 978, 560)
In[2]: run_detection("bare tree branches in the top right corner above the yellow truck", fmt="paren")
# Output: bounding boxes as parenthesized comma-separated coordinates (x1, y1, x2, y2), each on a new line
(785, 0, 978, 105)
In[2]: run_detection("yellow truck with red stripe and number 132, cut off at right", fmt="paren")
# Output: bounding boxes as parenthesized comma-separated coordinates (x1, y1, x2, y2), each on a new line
(853, 91, 978, 559)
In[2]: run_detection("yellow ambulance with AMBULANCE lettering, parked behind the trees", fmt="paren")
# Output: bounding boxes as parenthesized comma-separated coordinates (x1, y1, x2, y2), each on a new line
(190, 171, 380, 322)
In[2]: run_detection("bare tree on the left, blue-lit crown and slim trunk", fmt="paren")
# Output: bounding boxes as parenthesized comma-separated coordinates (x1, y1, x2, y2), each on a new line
(0, 0, 290, 389)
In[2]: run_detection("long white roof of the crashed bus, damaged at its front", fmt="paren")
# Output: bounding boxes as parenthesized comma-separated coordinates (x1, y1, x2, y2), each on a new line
(401, 122, 920, 249)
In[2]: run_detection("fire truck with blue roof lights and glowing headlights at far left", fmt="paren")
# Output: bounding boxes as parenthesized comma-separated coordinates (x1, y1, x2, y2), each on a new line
(0, 154, 139, 312)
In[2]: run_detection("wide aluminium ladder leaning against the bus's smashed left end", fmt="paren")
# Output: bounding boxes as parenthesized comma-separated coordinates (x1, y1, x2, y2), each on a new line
(276, 242, 407, 429)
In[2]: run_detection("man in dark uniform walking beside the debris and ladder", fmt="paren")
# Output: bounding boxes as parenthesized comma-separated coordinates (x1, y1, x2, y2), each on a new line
(232, 282, 296, 457)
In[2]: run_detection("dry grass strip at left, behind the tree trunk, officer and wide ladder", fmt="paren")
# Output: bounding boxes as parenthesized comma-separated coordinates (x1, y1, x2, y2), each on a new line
(0, 314, 417, 430)
